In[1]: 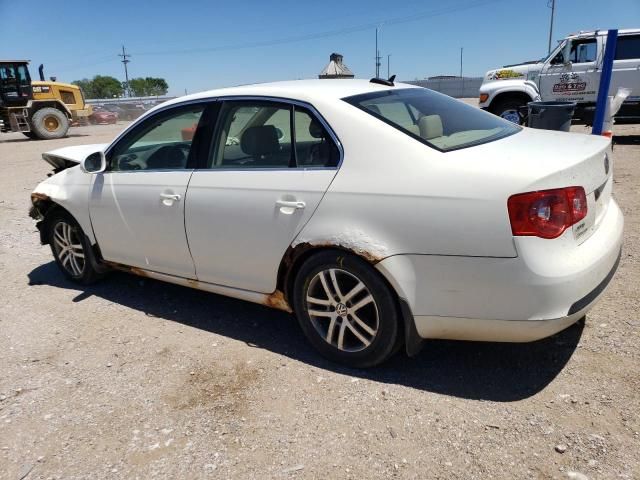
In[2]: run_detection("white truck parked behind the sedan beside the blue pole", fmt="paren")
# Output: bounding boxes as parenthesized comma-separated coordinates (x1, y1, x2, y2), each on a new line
(480, 29, 640, 124)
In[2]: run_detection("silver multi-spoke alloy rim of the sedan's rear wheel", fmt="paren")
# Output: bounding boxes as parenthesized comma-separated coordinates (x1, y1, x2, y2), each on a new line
(306, 268, 380, 352)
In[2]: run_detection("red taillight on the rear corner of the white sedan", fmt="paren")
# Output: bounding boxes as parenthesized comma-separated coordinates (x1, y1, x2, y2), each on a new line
(507, 187, 587, 238)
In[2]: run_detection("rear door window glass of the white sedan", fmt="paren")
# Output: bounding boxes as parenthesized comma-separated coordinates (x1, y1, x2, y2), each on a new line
(207, 100, 340, 169)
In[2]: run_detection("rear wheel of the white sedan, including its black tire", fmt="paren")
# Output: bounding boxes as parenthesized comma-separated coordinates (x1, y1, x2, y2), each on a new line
(293, 251, 400, 368)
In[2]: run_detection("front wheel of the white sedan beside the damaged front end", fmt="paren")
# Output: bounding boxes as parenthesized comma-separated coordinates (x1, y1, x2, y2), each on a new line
(45, 210, 102, 285)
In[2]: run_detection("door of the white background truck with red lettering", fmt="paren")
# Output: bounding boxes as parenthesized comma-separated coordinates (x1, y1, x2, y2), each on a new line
(540, 37, 600, 102)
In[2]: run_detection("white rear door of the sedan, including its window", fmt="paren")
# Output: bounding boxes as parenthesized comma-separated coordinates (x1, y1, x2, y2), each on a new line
(185, 100, 340, 293)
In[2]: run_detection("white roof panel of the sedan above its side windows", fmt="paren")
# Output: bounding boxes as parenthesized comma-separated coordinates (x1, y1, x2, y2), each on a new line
(162, 79, 420, 110)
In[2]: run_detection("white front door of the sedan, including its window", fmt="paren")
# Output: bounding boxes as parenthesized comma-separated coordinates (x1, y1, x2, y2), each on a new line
(89, 104, 204, 278)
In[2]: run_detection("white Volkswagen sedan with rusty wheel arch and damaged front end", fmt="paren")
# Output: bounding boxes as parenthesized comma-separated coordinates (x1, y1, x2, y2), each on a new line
(31, 79, 623, 367)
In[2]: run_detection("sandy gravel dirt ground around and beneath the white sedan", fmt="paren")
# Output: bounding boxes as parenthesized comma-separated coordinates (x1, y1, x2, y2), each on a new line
(0, 117, 640, 480)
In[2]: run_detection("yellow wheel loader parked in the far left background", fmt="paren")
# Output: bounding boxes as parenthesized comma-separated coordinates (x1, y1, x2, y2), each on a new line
(0, 60, 92, 140)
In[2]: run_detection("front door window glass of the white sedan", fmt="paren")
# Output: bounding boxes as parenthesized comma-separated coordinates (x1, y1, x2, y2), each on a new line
(109, 105, 204, 171)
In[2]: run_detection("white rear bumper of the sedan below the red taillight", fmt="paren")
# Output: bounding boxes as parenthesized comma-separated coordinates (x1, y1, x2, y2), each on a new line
(377, 200, 624, 342)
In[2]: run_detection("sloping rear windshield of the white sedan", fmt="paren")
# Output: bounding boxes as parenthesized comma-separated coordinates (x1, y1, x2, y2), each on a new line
(343, 88, 521, 152)
